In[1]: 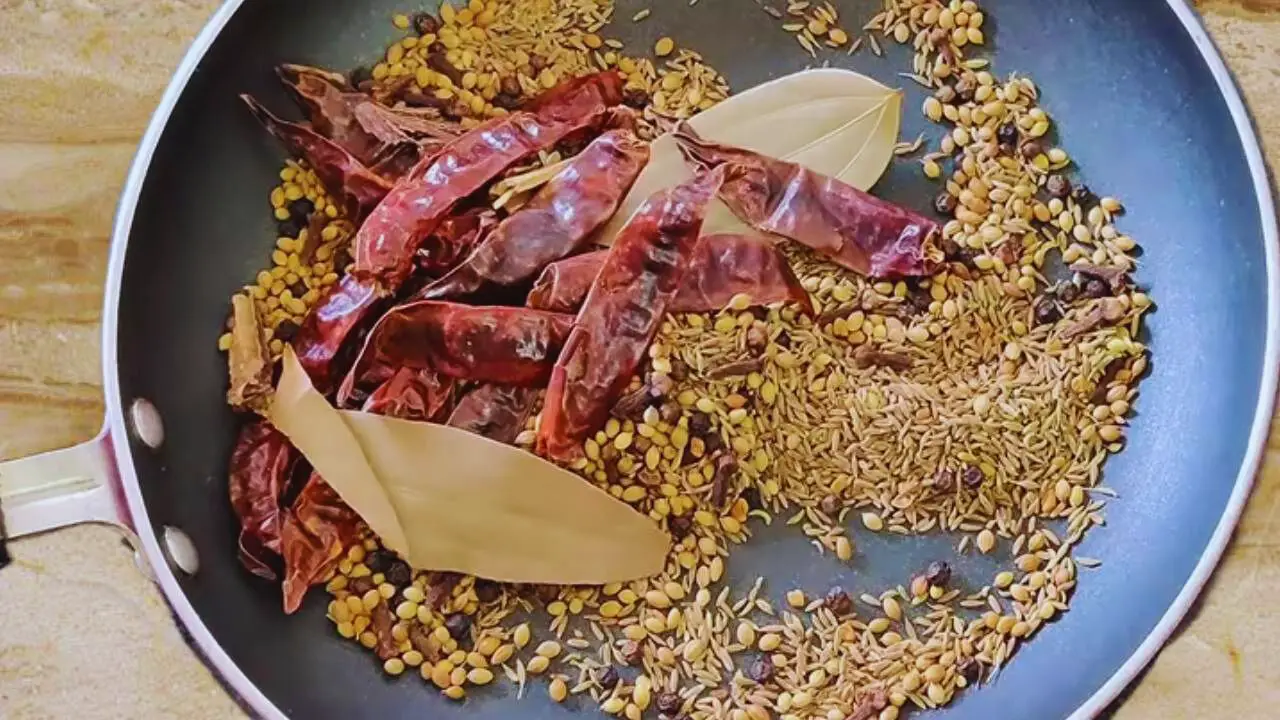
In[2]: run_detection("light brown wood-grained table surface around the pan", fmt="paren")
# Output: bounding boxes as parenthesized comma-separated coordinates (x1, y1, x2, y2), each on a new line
(0, 0, 1280, 719)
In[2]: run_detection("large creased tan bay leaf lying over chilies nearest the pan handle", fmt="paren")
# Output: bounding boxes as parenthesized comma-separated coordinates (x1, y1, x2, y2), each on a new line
(269, 347, 671, 584)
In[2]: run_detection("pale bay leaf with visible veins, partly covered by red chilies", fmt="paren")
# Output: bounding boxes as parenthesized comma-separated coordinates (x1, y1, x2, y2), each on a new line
(595, 68, 902, 246)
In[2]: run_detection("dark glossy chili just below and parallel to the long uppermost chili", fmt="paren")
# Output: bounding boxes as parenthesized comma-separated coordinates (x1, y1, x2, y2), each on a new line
(413, 129, 649, 300)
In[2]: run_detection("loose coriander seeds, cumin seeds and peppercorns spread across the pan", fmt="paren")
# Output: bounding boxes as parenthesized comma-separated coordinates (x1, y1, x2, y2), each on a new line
(220, 0, 1151, 720)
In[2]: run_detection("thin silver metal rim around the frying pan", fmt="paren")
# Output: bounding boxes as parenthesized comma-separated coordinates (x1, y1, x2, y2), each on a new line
(102, 0, 1280, 720)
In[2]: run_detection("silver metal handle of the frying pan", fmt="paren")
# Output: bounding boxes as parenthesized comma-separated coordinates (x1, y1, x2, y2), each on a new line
(0, 429, 137, 538)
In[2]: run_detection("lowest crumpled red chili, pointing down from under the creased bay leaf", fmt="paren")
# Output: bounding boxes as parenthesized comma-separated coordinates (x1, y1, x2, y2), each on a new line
(280, 473, 362, 614)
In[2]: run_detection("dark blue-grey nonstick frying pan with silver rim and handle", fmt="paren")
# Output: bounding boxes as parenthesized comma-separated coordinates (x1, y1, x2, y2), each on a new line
(0, 0, 1280, 719)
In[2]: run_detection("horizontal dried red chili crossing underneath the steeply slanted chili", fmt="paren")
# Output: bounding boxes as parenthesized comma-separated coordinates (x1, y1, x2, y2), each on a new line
(526, 233, 813, 314)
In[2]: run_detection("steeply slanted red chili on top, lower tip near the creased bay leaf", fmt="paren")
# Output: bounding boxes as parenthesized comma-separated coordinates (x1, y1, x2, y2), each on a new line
(538, 170, 723, 461)
